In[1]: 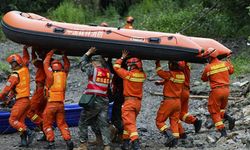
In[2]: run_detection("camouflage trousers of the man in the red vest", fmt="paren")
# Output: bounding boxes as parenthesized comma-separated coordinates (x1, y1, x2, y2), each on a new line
(78, 96, 111, 145)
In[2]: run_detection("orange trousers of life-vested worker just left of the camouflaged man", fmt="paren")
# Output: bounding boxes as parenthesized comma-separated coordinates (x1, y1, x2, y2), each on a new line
(43, 102, 71, 142)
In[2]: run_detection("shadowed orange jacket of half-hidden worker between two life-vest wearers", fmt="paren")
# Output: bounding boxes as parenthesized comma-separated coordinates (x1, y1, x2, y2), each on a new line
(32, 50, 46, 85)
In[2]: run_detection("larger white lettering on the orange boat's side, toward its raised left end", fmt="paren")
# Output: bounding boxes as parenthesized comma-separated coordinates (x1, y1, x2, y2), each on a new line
(65, 30, 103, 38)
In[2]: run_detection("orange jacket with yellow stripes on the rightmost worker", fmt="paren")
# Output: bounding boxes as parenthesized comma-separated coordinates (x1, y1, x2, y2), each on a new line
(201, 58, 234, 89)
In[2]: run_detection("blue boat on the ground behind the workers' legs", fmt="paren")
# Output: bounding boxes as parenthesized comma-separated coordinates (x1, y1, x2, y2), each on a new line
(0, 103, 113, 134)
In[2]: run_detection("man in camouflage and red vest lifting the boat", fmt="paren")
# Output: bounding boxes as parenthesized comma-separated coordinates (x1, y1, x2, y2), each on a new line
(79, 47, 111, 150)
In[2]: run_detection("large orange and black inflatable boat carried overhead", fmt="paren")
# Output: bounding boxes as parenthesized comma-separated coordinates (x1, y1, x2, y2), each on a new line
(2, 11, 231, 63)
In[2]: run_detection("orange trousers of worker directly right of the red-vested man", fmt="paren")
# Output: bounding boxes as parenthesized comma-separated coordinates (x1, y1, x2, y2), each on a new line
(122, 98, 141, 141)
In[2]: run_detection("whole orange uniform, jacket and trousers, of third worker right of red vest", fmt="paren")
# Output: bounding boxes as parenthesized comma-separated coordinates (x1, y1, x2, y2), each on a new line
(156, 63, 185, 138)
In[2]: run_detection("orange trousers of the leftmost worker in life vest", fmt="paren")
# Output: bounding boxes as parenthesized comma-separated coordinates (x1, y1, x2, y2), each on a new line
(9, 97, 30, 132)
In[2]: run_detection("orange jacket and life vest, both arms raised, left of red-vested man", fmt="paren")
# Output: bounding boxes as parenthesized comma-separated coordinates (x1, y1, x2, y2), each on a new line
(44, 51, 70, 101)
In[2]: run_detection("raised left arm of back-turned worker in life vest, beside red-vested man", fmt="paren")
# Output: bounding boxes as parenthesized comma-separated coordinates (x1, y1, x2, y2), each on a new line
(43, 50, 54, 86)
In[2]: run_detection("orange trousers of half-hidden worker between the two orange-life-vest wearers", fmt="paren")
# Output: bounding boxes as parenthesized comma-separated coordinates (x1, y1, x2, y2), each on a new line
(27, 87, 47, 126)
